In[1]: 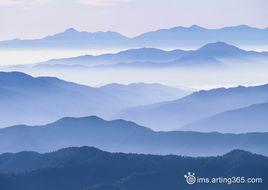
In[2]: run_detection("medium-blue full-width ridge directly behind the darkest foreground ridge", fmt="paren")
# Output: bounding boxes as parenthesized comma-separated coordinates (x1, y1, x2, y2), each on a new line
(0, 116, 268, 156)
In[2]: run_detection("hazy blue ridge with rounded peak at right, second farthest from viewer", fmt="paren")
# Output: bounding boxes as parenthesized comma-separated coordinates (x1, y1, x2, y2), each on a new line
(35, 42, 268, 68)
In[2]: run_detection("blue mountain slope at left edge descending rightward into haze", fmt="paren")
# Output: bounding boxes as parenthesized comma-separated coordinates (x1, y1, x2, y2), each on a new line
(0, 72, 115, 127)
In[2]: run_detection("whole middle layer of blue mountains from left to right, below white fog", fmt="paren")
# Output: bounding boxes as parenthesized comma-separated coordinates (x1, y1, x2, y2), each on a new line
(0, 72, 268, 133)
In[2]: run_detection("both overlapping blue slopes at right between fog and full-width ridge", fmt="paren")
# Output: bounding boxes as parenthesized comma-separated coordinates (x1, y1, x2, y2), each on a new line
(115, 84, 268, 133)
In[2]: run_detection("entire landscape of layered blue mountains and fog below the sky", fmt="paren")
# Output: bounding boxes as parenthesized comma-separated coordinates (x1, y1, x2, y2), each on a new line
(0, 25, 268, 190)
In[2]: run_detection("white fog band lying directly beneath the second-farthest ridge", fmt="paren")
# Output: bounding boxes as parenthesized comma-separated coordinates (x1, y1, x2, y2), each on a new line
(1, 66, 268, 89)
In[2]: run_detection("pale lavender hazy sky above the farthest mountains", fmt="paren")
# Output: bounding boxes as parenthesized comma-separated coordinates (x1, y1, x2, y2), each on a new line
(0, 0, 268, 40)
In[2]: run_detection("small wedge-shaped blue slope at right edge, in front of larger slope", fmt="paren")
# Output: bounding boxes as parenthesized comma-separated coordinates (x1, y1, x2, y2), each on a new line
(181, 103, 268, 133)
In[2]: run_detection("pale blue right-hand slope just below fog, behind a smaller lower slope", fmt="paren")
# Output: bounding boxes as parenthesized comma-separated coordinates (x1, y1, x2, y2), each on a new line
(116, 85, 268, 133)
